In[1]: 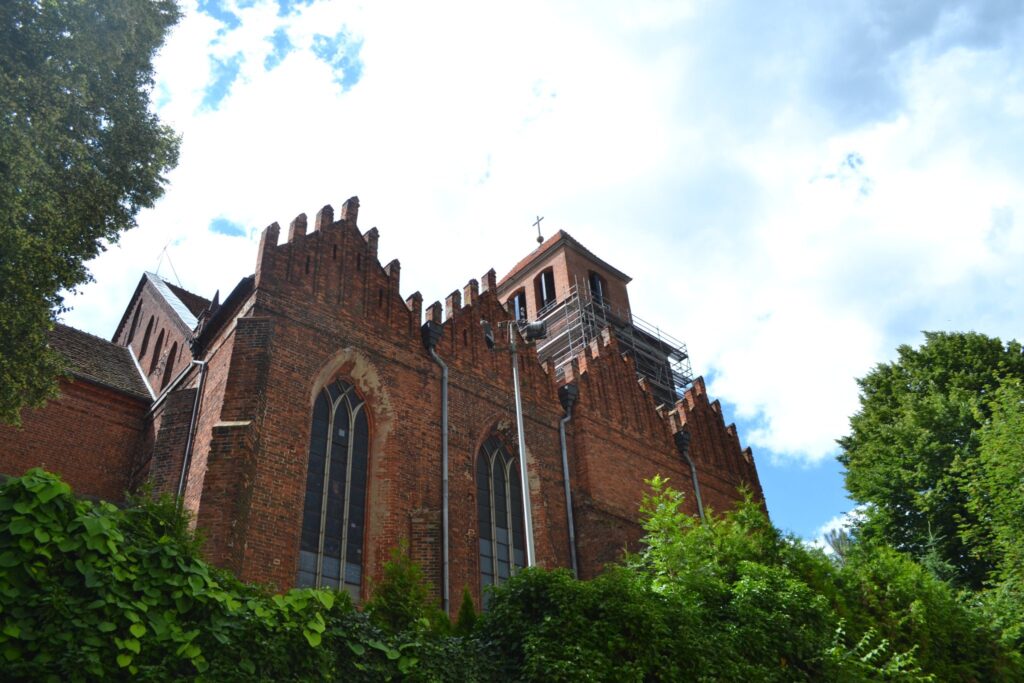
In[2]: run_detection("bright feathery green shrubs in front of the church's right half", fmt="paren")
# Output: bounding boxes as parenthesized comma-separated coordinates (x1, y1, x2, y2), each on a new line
(477, 478, 1024, 683)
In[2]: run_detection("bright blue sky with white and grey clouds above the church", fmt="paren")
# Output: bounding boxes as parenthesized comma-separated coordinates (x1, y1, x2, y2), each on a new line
(65, 0, 1024, 540)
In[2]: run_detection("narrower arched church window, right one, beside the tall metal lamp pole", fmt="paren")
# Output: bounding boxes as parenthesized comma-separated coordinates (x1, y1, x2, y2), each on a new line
(476, 436, 526, 604)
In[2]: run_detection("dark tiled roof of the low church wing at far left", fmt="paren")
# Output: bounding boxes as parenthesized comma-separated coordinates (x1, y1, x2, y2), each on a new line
(50, 323, 152, 400)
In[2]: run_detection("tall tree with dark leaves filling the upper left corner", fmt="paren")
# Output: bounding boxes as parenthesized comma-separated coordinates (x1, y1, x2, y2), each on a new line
(0, 0, 179, 424)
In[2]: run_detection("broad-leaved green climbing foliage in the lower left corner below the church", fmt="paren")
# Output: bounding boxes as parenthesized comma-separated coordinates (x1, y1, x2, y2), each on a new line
(0, 470, 487, 681)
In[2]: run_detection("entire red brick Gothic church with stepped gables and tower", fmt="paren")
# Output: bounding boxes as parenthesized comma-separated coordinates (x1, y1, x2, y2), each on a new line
(0, 198, 763, 610)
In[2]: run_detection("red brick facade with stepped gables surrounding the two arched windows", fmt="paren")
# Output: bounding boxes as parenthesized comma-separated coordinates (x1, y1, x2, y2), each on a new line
(178, 198, 761, 600)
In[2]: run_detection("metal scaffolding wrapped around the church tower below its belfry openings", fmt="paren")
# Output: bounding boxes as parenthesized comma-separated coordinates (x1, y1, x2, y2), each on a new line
(537, 282, 693, 405)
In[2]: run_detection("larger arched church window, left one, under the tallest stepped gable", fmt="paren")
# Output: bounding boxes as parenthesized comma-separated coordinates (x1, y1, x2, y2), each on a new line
(296, 380, 370, 599)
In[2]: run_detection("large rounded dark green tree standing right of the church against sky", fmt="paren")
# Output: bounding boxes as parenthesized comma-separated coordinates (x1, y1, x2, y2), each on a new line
(839, 332, 1024, 589)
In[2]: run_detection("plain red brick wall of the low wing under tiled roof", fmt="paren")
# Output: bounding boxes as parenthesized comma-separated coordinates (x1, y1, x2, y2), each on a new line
(0, 381, 146, 502)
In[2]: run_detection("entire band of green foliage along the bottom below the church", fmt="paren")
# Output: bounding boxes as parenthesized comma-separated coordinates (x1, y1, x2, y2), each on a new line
(6, 470, 1024, 683)
